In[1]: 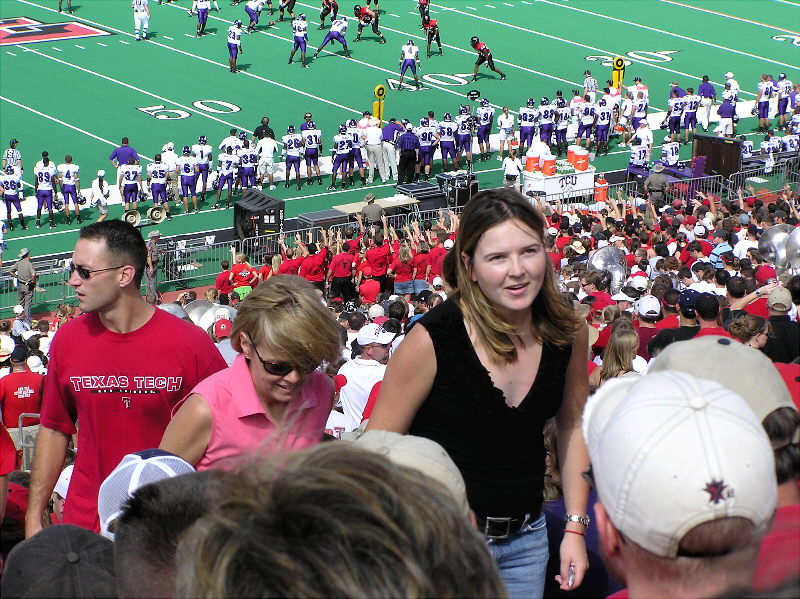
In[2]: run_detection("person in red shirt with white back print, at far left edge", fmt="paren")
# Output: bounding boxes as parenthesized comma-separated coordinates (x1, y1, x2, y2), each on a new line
(0, 345, 44, 432)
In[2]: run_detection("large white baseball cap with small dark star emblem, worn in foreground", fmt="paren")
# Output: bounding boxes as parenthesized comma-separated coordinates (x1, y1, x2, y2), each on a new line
(583, 370, 777, 558)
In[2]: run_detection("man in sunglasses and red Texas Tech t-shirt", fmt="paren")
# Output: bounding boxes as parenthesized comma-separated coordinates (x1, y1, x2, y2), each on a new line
(25, 220, 226, 537)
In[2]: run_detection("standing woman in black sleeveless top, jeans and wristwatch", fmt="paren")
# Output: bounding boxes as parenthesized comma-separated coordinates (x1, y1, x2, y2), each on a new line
(368, 189, 588, 597)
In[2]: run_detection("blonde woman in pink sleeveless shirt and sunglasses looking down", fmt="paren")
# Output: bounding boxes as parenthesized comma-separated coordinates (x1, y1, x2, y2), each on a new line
(160, 275, 341, 470)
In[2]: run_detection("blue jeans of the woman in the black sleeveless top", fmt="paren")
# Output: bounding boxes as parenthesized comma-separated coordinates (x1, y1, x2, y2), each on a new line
(489, 514, 549, 599)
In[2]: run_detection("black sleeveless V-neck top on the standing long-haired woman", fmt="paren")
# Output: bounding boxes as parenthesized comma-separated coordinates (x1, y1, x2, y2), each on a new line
(409, 300, 572, 518)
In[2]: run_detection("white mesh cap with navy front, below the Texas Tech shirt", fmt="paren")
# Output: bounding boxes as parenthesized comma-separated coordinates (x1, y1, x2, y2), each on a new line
(97, 449, 195, 541)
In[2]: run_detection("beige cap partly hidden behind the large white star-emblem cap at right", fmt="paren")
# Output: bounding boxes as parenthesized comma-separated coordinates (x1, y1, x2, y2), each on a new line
(648, 335, 795, 421)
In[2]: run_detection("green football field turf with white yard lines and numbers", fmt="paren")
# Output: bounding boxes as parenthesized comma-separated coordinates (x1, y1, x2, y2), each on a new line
(0, 0, 800, 306)
